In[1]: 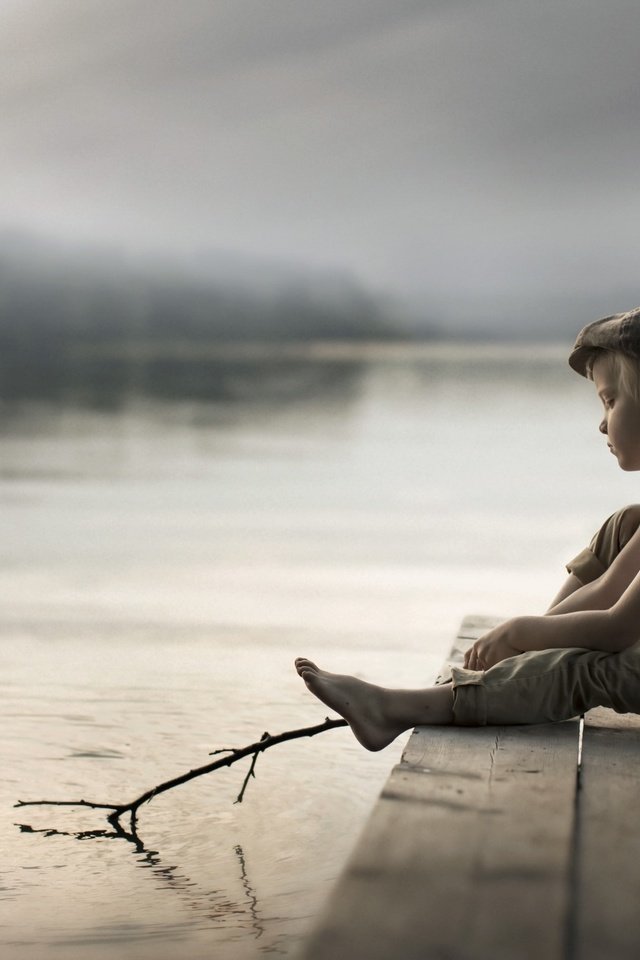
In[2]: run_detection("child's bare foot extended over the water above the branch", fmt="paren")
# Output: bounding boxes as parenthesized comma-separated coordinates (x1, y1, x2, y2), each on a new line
(295, 657, 407, 750)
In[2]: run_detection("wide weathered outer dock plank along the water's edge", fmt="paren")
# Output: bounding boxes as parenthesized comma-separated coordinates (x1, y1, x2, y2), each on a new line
(303, 618, 578, 960)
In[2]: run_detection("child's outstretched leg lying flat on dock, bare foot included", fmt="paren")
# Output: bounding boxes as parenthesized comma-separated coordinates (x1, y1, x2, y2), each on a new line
(296, 645, 640, 750)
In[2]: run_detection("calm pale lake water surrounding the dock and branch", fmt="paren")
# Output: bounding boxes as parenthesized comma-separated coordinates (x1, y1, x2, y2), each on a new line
(0, 345, 638, 960)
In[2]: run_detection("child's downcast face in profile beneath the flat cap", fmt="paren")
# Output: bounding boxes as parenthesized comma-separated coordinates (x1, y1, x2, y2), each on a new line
(593, 356, 640, 470)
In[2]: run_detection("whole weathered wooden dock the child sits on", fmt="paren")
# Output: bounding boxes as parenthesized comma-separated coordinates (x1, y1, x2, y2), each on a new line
(301, 617, 640, 960)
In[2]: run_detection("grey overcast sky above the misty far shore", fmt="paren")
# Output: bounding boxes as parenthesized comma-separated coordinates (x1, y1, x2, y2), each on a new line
(0, 0, 640, 325)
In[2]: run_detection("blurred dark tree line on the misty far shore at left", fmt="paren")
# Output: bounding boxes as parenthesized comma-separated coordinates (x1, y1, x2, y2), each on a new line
(0, 236, 422, 360)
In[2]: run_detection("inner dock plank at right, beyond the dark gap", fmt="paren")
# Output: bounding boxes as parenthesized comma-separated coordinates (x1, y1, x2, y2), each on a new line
(575, 708, 640, 960)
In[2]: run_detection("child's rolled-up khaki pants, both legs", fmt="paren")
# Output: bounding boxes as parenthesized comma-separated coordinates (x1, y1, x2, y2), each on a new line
(451, 506, 640, 726)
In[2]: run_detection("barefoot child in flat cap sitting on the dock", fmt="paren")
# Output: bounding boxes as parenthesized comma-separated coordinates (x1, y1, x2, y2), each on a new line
(295, 307, 640, 750)
